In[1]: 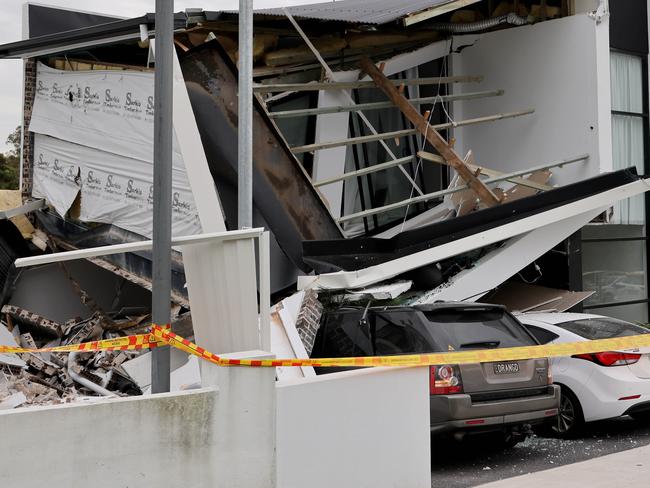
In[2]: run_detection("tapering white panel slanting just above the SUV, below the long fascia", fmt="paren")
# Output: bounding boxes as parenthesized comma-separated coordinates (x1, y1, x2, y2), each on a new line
(413, 205, 609, 305)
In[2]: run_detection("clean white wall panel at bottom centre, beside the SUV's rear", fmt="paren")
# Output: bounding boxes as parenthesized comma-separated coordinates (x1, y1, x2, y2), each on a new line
(277, 367, 431, 488)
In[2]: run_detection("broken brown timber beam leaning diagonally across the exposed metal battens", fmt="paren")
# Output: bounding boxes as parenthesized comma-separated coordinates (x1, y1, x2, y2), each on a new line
(361, 58, 500, 207)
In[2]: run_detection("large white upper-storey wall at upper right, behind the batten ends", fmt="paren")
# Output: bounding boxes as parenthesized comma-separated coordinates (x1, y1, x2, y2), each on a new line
(452, 14, 612, 185)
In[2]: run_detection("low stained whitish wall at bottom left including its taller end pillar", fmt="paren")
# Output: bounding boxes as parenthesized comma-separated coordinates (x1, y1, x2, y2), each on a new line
(0, 352, 276, 488)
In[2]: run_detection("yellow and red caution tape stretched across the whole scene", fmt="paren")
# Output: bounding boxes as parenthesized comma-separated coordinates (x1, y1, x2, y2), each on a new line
(0, 325, 650, 367)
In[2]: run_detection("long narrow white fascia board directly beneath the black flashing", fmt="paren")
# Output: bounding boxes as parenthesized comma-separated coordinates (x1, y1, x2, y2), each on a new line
(298, 179, 650, 290)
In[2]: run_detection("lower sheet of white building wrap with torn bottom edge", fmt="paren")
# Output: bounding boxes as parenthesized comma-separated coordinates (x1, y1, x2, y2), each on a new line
(33, 134, 201, 237)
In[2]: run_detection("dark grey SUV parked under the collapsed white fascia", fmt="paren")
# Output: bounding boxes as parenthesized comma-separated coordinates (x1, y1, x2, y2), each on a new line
(312, 303, 560, 444)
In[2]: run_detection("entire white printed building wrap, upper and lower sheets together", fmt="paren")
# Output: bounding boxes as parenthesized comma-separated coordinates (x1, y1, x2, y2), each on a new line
(29, 64, 201, 237)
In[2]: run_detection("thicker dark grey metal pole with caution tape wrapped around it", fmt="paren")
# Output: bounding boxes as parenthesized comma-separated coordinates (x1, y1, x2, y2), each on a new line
(151, 0, 174, 393)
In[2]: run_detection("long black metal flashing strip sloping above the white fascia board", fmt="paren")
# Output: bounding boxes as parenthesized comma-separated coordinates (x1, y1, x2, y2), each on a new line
(303, 168, 639, 272)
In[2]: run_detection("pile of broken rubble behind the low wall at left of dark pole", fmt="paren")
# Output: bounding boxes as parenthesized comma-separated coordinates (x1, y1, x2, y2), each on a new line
(0, 305, 150, 410)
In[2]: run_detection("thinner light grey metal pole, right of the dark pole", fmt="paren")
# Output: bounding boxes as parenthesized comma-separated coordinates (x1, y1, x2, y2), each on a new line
(237, 0, 253, 229)
